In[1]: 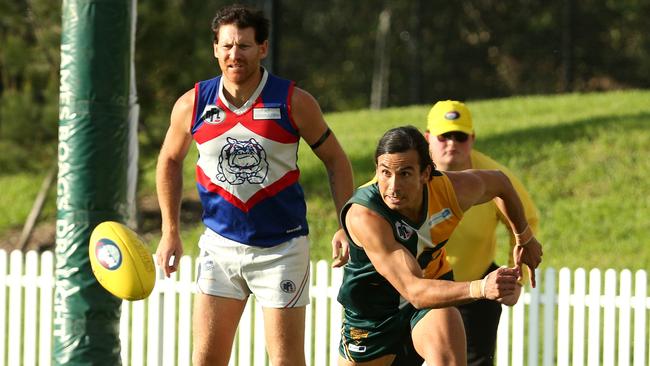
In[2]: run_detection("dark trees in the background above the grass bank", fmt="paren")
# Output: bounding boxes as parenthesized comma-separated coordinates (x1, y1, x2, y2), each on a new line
(0, 0, 650, 174)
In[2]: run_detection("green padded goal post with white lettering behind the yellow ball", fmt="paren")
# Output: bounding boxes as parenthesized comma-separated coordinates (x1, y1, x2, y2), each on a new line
(53, 0, 134, 365)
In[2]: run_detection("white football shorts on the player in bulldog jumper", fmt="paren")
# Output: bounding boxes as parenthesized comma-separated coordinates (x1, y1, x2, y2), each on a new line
(196, 229, 309, 308)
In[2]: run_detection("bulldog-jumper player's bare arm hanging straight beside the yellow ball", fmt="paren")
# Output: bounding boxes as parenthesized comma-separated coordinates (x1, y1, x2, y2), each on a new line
(156, 90, 194, 277)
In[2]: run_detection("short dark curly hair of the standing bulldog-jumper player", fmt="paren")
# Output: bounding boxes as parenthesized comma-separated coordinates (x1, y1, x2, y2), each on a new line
(212, 4, 269, 44)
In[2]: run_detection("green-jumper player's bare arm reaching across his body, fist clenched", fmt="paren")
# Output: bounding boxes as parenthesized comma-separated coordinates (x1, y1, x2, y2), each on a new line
(346, 205, 518, 308)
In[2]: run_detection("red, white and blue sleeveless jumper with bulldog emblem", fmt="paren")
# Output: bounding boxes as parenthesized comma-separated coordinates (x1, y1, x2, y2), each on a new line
(191, 69, 309, 247)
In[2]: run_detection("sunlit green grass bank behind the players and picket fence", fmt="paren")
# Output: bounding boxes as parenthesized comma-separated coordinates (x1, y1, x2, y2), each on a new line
(0, 91, 650, 269)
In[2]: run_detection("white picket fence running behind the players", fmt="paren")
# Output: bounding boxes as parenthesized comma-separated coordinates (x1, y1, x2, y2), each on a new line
(0, 251, 650, 366)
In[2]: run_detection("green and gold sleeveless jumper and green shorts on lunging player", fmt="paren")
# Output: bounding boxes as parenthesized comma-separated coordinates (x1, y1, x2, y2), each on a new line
(337, 171, 463, 362)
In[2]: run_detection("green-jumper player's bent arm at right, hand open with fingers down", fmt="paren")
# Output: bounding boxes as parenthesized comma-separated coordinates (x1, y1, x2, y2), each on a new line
(445, 170, 543, 287)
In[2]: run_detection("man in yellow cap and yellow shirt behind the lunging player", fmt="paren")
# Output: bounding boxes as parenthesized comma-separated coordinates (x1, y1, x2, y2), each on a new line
(425, 100, 539, 366)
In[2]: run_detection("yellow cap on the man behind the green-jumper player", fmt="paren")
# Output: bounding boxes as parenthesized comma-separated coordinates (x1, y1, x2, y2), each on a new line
(427, 100, 474, 135)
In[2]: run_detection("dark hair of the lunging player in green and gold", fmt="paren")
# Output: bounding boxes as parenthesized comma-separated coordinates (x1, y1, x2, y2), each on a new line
(375, 125, 436, 175)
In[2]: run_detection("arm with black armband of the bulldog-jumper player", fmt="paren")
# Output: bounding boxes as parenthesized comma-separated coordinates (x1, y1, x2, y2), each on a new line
(291, 88, 354, 267)
